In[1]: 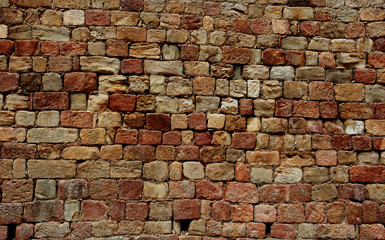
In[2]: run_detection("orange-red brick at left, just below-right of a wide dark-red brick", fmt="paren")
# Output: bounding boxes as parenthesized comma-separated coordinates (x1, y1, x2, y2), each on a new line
(60, 111, 94, 128)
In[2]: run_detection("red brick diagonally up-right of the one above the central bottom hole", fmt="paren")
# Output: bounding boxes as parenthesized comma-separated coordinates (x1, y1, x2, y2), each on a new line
(195, 180, 224, 200)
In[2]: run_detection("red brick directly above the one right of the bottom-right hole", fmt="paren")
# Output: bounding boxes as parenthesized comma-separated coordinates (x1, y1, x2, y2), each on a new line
(277, 204, 305, 223)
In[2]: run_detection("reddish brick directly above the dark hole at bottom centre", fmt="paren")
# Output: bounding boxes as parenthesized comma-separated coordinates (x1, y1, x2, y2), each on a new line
(173, 199, 201, 220)
